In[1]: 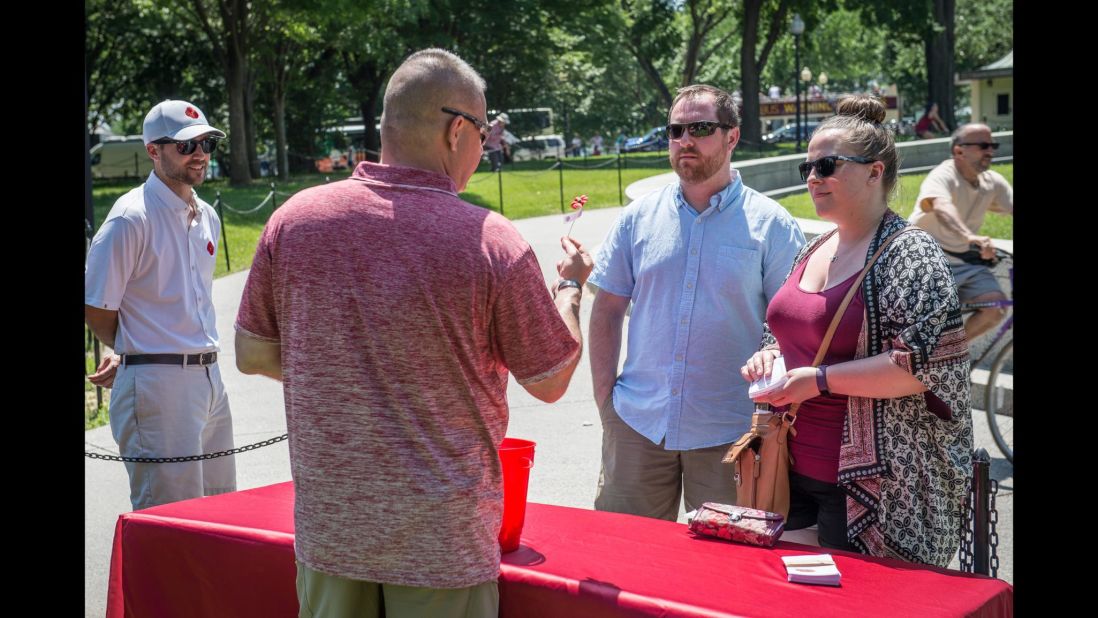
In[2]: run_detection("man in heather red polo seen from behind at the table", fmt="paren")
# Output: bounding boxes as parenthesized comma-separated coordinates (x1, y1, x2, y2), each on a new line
(236, 49, 592, 617)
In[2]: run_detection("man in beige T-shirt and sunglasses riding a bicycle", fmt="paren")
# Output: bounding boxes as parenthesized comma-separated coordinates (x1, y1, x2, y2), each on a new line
(909, 123, 1015, 341)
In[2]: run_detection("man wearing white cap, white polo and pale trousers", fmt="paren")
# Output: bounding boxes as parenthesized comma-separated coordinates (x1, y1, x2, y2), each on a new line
(83, 101, 236, 510)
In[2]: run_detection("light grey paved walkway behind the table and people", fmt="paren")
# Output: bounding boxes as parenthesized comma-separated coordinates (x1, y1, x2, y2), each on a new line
(85, 195, 1013, 618)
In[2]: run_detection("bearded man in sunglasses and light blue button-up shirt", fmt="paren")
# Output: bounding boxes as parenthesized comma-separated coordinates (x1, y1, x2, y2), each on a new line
(587, 86, 805, 520)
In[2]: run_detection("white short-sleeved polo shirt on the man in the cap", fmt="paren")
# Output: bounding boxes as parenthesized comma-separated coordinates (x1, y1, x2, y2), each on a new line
(83, 171, 221, 353)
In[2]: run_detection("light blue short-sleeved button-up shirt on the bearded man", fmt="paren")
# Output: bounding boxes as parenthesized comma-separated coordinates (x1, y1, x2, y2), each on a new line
(590, 170, 805, 450)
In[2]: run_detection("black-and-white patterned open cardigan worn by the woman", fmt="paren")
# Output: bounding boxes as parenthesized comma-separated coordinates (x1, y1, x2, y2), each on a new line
(762, 210, 972, 566)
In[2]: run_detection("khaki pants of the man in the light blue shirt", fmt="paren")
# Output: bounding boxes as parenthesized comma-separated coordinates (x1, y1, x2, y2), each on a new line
(595, 396, 736, 521)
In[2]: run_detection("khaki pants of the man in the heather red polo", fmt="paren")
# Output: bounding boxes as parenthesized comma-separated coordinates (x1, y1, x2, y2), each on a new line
(298, 562, 500, 618)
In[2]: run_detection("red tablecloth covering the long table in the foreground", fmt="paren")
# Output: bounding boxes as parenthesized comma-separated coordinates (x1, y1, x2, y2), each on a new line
(107, 483, 1013, 618)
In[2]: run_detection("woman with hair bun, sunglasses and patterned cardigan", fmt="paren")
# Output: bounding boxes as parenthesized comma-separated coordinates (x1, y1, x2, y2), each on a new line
(740, 95, 972, 566)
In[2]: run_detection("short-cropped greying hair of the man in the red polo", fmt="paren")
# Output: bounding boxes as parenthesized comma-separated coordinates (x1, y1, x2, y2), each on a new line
(381, 47, 488, 146)
